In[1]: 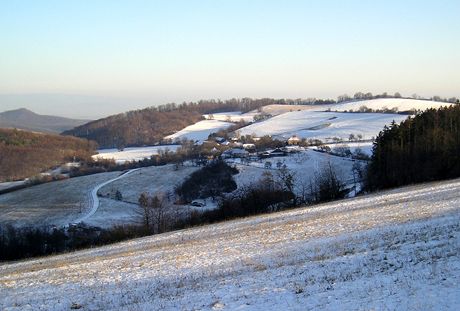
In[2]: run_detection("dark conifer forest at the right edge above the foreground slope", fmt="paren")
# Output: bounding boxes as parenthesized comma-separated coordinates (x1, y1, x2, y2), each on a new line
(367, 105, 460, 190)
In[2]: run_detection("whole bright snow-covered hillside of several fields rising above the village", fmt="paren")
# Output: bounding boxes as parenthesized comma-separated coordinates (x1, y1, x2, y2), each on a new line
(166, 98, 448, 145)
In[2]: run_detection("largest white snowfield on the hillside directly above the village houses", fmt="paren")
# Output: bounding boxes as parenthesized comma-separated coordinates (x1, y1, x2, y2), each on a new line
(239, 110, 407, 141)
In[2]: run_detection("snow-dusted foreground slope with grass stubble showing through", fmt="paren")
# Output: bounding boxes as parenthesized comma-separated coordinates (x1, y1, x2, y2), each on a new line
(0, 180, 460, 310)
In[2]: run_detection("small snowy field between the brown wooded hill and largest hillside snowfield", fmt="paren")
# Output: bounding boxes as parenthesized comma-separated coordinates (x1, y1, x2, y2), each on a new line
(165, 120, 233, 142)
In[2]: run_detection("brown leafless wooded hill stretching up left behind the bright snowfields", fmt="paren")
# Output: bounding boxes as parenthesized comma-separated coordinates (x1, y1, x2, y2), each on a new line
(63, 98, 282, 148)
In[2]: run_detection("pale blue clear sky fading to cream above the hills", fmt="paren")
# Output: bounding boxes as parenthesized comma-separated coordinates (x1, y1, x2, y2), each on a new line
(0, 0, 460, 118)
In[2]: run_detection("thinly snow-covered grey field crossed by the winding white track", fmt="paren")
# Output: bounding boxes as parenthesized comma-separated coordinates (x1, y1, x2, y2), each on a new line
(0, 164, 197, 228)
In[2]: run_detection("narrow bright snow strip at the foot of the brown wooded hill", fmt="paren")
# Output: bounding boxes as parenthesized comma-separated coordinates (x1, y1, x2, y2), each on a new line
(93, 145, 180, 163)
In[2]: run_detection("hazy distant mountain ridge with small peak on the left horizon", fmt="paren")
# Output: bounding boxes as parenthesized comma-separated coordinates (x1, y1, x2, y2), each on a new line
(0, 108, 89, 133)
